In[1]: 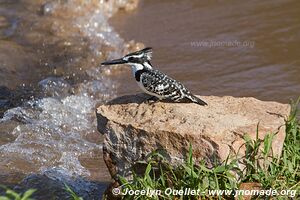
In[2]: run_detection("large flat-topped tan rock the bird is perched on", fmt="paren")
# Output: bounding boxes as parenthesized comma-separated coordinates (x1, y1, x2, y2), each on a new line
(97, 94, 290, 178)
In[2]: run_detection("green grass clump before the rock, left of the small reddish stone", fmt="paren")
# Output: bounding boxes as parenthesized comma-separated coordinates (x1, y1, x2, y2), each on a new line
(120, 145, 240, 199)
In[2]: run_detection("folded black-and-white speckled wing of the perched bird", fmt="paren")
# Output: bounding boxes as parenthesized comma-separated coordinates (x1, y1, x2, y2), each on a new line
(141, 70, 188, 99)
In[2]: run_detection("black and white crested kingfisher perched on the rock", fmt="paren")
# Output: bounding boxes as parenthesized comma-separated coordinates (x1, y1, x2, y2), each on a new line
(101, 47, 207, 106)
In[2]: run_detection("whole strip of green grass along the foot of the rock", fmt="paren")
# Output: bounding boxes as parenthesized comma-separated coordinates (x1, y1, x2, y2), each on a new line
(111, 101, 300, 200)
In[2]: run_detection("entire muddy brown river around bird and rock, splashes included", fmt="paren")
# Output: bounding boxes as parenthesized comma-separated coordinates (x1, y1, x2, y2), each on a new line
(0, 0, 300, 198)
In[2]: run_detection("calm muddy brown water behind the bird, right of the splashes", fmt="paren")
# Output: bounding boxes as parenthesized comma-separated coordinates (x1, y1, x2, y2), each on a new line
(111, 0, 300, 103)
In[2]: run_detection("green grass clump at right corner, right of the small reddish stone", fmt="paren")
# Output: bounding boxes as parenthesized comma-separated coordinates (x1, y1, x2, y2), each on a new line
(242, 101, 300, 191)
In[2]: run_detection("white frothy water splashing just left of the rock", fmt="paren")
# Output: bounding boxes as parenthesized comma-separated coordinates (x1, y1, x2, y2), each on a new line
(0, 75, 113, 176)
